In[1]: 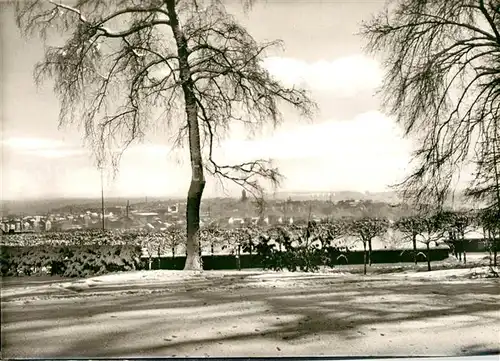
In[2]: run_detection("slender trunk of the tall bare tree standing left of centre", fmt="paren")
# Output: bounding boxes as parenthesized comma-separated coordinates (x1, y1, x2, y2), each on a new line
(165, 0, 205, 270)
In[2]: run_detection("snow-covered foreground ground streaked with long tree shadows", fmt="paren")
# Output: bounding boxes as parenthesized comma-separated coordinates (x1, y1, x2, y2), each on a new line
(1, 267, 500, 358)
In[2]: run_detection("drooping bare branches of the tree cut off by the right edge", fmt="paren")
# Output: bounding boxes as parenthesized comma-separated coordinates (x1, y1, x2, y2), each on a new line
(361, 0, 500, 205)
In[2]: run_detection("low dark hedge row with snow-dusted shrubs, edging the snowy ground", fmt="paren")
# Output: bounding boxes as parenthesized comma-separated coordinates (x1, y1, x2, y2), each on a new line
(0, 235, 454, 277)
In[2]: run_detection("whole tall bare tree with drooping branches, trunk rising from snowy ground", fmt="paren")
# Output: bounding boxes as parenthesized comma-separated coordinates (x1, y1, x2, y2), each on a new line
(16, 0, 315, 269)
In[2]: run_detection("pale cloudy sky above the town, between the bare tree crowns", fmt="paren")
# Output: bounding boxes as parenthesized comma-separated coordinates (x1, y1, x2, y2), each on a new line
(0, 0, 418, 199)
